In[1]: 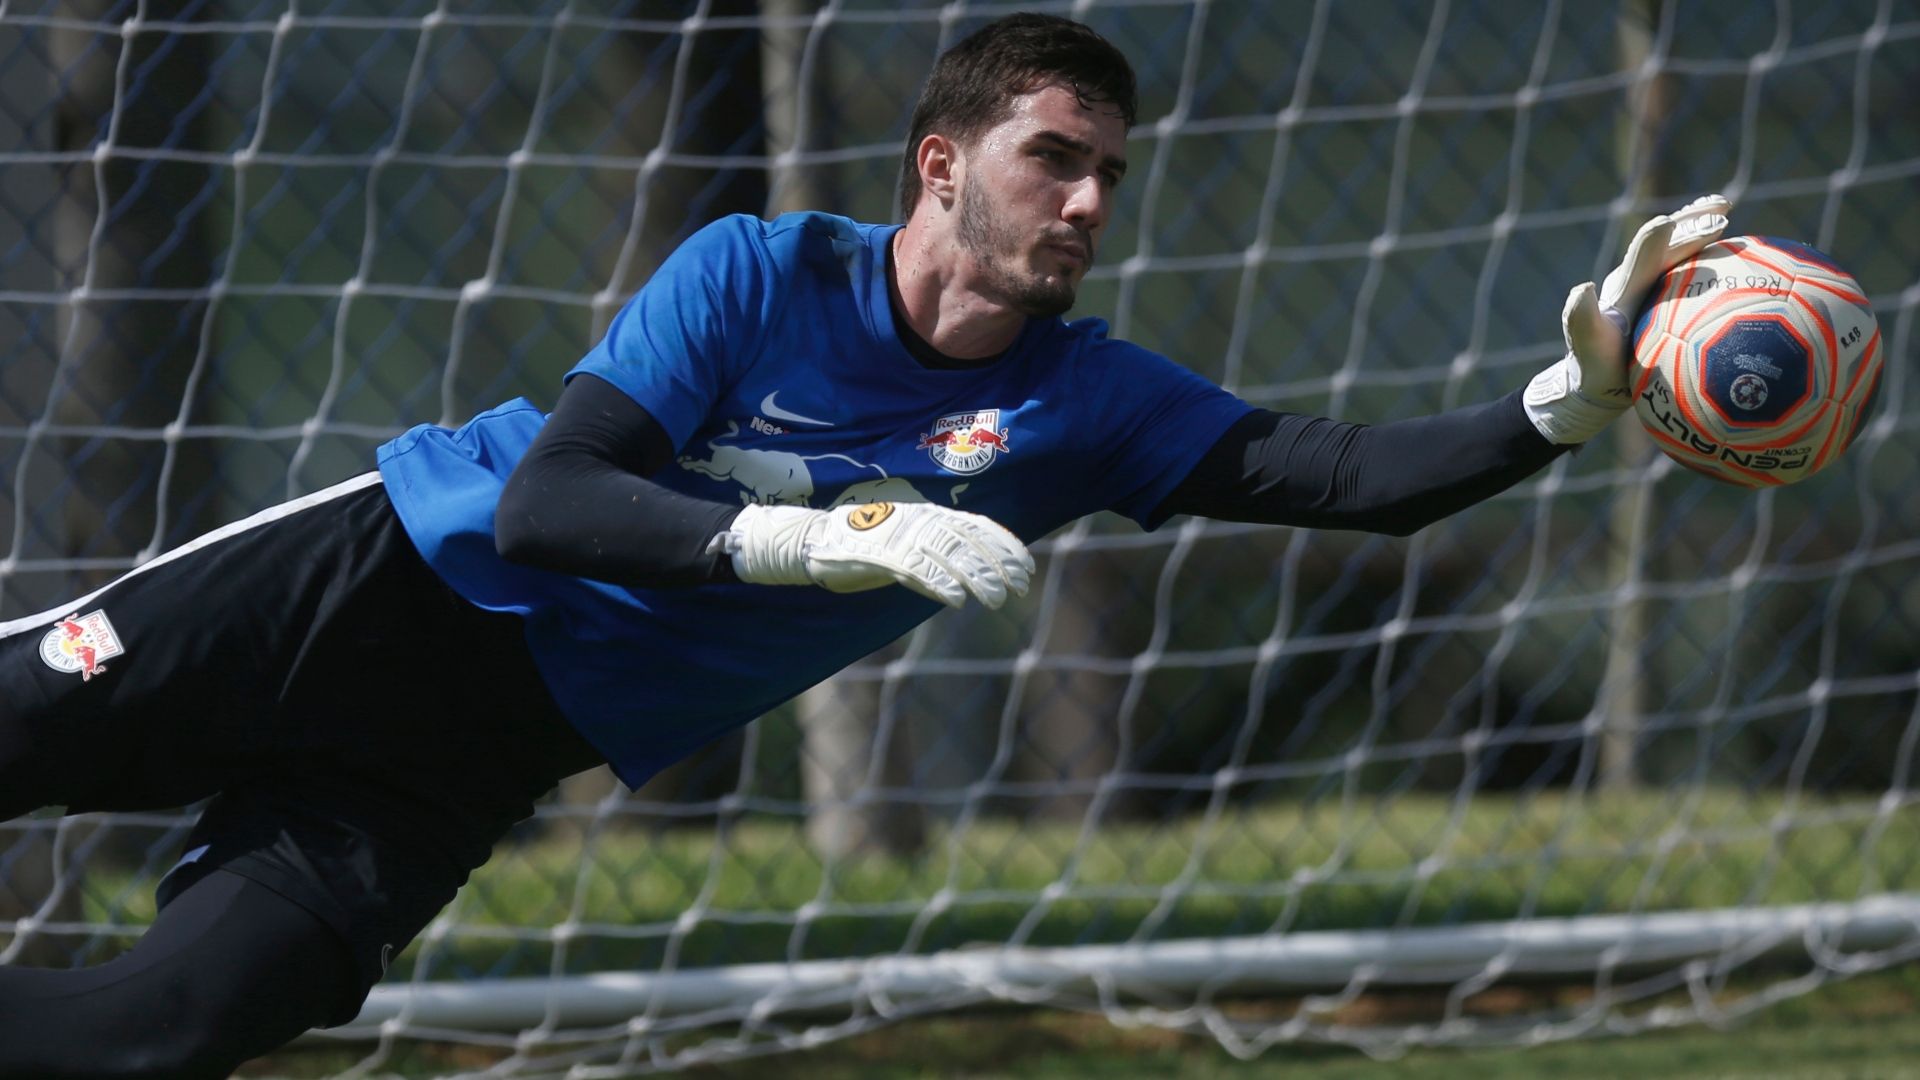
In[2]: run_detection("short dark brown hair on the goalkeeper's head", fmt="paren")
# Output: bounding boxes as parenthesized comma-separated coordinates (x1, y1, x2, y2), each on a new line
(900, 12, 1139, 221)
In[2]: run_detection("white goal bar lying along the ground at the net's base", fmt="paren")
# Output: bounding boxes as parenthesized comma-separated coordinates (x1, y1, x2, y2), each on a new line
(322, 896, 1920, 1047)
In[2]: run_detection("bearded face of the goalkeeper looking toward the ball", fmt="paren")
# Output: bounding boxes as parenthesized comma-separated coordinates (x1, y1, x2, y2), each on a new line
(956, 86, 1127, 317)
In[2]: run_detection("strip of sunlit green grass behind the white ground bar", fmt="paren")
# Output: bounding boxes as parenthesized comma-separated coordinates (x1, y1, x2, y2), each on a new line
(67, 790, 1920, 978)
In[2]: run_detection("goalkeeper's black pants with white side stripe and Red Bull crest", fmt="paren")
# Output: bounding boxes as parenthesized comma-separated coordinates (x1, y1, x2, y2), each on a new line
(0, 475, 599, 1078)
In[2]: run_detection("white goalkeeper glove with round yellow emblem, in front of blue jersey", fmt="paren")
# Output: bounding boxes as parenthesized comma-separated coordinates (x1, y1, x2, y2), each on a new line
(708, 502, 1033, 607)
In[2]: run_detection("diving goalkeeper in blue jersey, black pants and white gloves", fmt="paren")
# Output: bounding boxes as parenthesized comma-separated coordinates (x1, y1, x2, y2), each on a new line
(0, 15, 1730, 1080)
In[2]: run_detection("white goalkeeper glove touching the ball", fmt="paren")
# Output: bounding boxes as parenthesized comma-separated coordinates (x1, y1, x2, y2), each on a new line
(1521, 194, 1734, 442)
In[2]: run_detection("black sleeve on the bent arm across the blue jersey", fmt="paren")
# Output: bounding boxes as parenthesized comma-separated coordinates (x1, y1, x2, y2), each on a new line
(493, 375, 739, 588)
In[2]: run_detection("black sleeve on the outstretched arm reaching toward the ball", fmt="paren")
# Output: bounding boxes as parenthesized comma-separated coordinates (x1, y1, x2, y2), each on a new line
(1162, 392, 1567, 536)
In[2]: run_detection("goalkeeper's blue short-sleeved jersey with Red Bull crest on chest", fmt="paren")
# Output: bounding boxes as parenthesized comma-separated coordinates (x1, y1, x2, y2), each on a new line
(380, 213, 1250, 786)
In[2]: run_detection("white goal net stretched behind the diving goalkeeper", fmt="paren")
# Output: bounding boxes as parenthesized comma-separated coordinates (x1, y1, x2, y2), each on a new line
(0, 0, 1920, 1076)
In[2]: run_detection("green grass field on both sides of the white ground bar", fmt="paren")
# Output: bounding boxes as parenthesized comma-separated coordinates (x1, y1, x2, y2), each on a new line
(48, 788, 1920, 1080)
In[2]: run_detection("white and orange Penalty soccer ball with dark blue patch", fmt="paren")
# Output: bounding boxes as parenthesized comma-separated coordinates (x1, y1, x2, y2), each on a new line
(1634, 236, 1882, 488)
